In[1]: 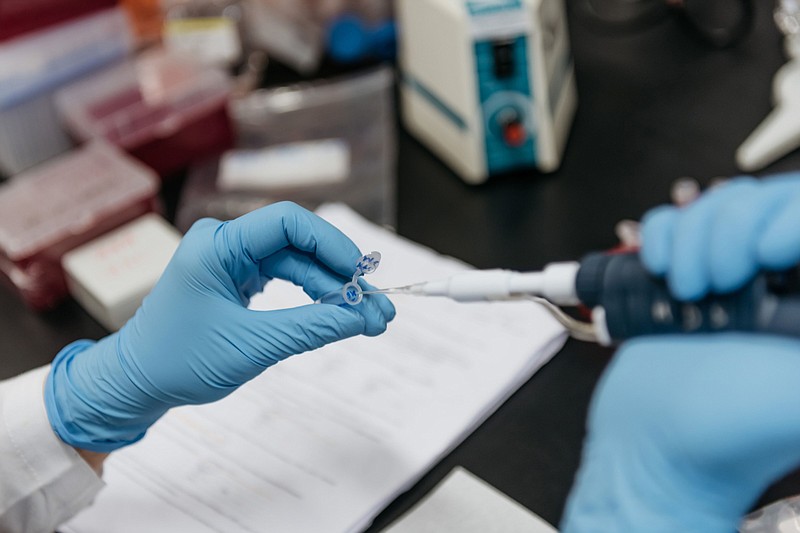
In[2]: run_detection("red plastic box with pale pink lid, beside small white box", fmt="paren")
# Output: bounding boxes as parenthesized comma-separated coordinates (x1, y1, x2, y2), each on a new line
(0, 141, 159, 310)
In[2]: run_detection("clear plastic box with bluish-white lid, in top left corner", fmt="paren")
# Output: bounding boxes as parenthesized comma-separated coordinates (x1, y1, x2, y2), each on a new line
(0, 8, 132, 176)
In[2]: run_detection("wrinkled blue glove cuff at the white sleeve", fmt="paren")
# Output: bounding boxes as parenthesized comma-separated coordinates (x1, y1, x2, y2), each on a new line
(44, 340, 150, 453)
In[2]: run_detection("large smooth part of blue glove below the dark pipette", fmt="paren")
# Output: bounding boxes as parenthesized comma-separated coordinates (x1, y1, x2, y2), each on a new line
(561, 333, 800, 533)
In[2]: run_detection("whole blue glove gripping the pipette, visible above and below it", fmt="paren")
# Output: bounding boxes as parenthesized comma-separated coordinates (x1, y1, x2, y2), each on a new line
(562, 174, 800, 533)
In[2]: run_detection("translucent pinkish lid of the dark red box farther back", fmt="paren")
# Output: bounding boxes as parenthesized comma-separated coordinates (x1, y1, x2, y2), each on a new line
(56, 49, 231, 148)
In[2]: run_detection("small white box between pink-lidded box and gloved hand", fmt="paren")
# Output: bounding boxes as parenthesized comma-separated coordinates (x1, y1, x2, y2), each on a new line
(61, 213, 181, 331)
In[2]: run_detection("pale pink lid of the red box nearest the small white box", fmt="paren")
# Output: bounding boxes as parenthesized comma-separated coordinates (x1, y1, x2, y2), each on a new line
(0, 141, 159, 261)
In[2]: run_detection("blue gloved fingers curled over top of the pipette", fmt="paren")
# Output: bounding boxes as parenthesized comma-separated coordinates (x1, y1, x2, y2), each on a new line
(641, 173, 800, 300)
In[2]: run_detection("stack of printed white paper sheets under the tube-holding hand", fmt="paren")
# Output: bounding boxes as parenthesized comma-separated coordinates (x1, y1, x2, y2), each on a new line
(61, 205, 565, 533)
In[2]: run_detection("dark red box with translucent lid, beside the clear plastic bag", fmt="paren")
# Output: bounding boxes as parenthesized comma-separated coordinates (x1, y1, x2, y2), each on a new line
(56, 48, 233, 177)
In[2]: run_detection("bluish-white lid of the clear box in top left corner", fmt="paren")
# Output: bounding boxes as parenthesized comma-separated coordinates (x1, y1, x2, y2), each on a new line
(0, 8, 133, 110)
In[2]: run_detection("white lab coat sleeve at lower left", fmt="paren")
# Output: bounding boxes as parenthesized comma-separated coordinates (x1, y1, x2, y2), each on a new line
(0, 366, 103, 533)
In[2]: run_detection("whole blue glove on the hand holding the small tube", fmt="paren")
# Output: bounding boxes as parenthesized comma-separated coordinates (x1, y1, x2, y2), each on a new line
(45, 202, 394, 452)
